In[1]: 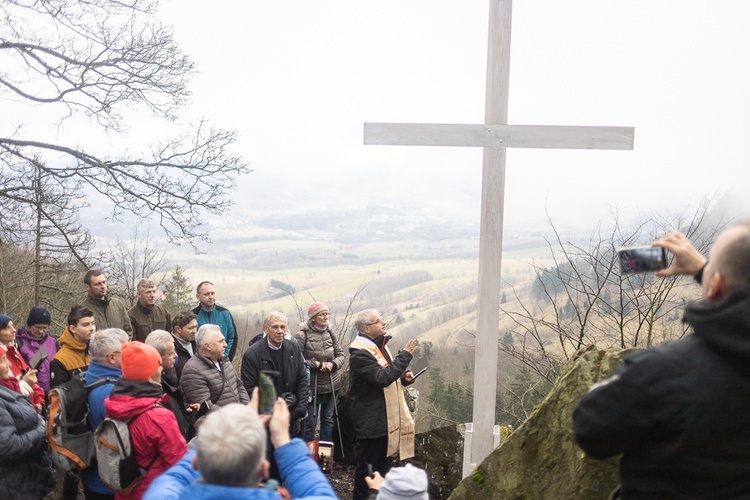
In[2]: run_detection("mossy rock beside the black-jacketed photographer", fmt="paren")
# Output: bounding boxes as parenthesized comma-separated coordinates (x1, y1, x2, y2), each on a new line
(450, 346, 634, 500)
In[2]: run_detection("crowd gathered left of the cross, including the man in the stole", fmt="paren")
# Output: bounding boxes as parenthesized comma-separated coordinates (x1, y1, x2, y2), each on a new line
(0, 270, 426, 500)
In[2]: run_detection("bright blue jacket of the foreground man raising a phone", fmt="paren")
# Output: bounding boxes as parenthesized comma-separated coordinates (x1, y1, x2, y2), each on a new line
(143, 439, 337, 500)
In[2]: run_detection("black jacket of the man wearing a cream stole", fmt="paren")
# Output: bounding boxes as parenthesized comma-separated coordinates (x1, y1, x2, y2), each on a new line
(349, 334, 412, 439)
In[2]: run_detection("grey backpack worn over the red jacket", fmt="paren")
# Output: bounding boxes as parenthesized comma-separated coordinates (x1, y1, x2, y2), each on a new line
(94, 412, 159, 495)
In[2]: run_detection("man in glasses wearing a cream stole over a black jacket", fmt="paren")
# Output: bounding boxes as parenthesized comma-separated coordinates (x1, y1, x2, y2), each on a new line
(349, 309, 417, 500)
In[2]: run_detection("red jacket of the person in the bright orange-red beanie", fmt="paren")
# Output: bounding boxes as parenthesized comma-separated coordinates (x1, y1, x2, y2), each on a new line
(104, 378, 187, 499)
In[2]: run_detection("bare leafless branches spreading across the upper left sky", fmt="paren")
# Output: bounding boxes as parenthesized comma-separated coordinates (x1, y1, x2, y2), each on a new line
(0, 0, 249, 249)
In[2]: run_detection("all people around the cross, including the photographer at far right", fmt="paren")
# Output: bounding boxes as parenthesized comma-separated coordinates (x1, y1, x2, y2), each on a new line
(0, 223, 750, 500)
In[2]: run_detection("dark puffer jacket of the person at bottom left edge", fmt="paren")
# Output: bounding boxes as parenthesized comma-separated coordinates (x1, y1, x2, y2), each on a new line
(0, 386, 55, 499)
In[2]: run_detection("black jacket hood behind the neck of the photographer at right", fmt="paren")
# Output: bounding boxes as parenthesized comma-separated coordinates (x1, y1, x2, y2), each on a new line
(683, 286, 750, 363)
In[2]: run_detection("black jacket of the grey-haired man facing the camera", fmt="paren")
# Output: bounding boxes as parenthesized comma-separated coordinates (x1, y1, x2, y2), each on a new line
(241, 338, 310, 428)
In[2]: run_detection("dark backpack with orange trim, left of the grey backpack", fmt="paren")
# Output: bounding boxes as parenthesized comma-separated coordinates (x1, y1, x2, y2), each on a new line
(45, 377, 117, 472)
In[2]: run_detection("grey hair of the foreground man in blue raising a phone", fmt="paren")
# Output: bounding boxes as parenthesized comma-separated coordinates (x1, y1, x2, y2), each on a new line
(195, 403, 266, 486)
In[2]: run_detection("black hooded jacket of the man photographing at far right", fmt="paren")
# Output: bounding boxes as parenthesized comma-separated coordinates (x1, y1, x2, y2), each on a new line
(573, 287, 750, 498)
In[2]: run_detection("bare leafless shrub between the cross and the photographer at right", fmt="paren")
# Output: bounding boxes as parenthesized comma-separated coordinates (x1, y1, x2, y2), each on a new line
(499, 200, 724, 382)
